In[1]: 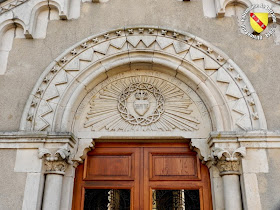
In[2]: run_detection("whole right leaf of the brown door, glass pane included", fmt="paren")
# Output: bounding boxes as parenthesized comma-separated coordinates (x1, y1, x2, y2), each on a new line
(143, 144, 212, 210)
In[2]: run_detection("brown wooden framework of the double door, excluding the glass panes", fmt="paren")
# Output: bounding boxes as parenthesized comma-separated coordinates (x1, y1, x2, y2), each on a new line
(72, 143, 212, 210)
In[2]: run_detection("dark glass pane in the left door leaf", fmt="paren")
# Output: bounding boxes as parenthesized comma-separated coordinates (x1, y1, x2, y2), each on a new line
(84, 189, 130, 210)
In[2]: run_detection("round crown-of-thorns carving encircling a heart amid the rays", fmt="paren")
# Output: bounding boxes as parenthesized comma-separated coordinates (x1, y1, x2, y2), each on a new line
(118, 82, 164, 126)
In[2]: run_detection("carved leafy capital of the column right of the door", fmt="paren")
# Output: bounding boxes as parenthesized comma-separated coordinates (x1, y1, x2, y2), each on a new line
(212, 147, 246, 176)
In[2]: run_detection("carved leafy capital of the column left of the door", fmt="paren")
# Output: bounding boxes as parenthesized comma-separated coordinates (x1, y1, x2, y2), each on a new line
(38, 146, 72, 175)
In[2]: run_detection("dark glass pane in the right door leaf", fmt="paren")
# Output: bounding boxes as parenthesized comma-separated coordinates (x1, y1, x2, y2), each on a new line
(152, 190, 200, 210)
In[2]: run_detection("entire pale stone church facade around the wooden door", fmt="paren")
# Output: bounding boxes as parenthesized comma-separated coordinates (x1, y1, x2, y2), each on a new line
(0, 0, 280, 210)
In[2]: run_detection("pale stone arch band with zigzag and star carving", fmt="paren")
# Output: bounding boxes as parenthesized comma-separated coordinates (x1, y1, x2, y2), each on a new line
(21, 27, 266, 135)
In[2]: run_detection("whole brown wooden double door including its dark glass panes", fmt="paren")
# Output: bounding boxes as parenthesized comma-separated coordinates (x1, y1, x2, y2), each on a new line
(73, 143, 212, 210)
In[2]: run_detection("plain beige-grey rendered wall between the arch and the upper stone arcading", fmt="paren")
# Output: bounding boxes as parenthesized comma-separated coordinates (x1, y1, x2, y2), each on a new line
(0, 1, 279, 130)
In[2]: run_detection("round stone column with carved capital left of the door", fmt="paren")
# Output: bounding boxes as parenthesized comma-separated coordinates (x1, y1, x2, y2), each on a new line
(39, 146, 71, 210)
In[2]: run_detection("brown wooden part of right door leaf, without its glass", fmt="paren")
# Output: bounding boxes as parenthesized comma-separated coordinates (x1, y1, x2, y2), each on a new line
(143, 144, 209, 210)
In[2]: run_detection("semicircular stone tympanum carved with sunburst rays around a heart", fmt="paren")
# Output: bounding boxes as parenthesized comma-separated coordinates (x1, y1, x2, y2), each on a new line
(84, 75, 200, 131)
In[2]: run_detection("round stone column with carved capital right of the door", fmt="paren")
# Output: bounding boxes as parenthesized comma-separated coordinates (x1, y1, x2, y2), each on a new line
(212, 147, 246, 210)
